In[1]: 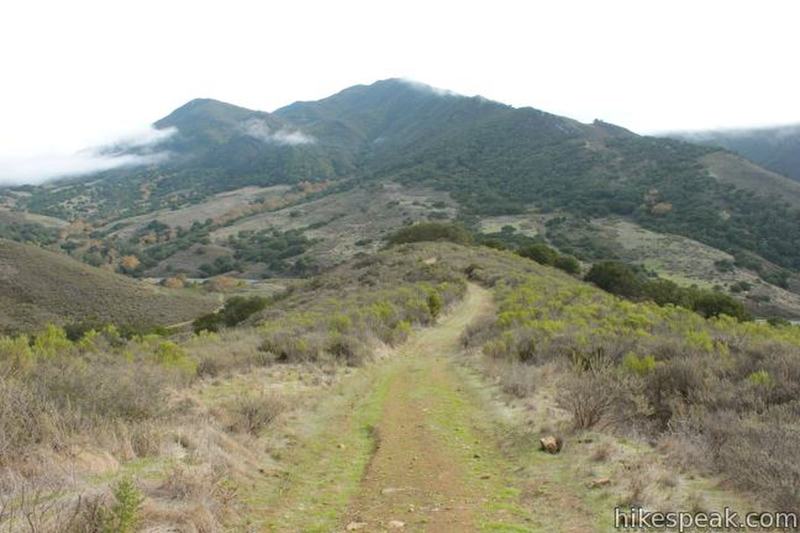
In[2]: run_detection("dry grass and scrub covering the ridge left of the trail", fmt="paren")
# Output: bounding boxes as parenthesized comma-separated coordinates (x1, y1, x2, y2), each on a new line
(0, 243, 482, 533)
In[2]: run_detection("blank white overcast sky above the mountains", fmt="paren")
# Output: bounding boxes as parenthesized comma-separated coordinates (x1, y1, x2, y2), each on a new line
(0, 0, 800, 181)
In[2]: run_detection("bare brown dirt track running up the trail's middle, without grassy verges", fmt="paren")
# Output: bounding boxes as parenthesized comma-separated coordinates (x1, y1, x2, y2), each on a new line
(347, 285, 500, 531)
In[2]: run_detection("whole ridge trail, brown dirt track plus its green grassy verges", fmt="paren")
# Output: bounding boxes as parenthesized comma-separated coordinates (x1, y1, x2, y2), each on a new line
(253, 284, 592, 532)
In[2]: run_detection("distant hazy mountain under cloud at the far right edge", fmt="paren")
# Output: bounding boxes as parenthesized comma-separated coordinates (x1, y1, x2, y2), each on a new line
(672, 124, 800, 181)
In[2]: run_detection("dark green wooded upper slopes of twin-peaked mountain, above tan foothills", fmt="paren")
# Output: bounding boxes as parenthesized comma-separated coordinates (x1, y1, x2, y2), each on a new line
(7, 79, 800, 278)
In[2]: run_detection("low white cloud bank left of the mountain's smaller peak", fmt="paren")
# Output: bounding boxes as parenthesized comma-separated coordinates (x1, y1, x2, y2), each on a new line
(0, 128, 176, 186)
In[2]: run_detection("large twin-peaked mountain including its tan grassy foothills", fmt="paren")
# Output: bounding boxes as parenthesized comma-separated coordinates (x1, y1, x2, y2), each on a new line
(5, 79, 800, 312)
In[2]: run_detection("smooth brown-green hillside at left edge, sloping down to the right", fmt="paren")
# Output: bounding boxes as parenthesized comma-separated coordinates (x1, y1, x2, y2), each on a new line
(0, 236, 216, 331)
